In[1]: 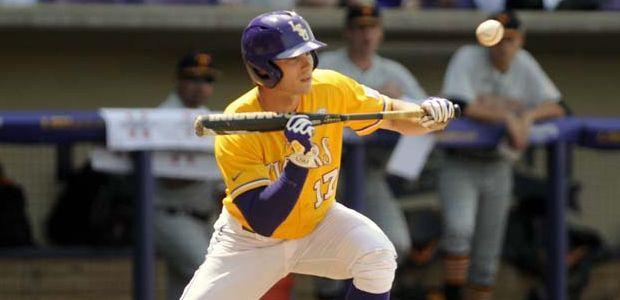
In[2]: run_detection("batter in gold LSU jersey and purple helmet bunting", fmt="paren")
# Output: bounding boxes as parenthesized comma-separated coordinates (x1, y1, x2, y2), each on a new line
(181, 11, 454, 299)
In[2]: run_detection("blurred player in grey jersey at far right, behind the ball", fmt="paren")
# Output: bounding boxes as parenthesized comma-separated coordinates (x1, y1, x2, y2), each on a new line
(439, 12, 565, 300)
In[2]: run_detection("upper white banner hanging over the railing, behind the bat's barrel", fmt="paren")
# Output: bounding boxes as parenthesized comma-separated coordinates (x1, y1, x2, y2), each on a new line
(100, 108, 214, 151)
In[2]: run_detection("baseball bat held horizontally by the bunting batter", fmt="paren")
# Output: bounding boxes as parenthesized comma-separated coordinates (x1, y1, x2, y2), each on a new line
(194, 105, 461, 136)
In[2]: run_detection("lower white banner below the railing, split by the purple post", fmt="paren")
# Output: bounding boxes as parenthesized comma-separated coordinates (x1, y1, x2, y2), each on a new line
(90, 148, 221, 180)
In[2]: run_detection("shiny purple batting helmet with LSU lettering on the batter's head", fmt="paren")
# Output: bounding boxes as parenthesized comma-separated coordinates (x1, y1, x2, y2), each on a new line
(241, 10, 326, 88)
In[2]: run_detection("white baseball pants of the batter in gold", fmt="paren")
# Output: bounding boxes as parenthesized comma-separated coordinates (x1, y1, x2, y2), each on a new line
(181, 203, 396, 300)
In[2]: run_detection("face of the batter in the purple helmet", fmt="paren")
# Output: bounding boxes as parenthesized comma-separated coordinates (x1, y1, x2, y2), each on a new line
(274, 53, 314, 95)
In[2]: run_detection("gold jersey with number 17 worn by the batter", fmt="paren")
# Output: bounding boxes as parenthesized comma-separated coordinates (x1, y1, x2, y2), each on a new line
(215, 69, 390, 239)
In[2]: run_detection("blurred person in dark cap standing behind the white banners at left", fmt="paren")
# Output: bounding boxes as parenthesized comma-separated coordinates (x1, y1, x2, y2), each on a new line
(155, 51, 220, 299)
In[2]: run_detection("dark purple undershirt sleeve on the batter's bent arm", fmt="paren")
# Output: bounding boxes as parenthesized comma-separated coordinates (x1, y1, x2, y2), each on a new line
(234, 163, 308, 236)
